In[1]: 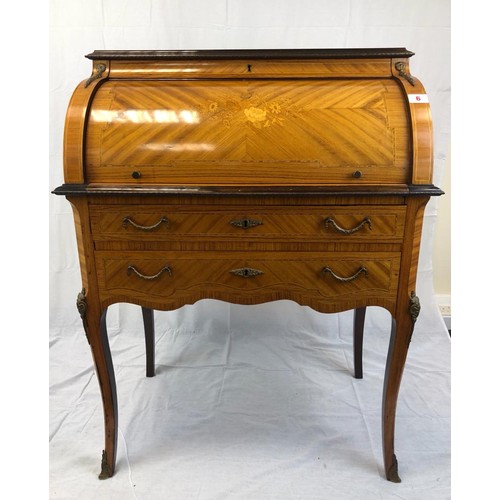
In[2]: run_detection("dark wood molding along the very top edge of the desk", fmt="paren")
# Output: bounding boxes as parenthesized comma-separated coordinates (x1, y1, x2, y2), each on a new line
(85, 47, 414, 61)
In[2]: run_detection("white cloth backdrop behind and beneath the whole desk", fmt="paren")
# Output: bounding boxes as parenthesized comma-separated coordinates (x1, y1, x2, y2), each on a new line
(49, 0, 450, 500)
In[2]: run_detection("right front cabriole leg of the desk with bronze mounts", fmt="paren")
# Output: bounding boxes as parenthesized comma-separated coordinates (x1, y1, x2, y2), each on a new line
(382, 292, 420, 483)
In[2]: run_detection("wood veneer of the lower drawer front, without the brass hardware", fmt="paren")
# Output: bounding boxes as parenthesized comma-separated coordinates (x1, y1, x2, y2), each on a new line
(96, 252, 399, 292)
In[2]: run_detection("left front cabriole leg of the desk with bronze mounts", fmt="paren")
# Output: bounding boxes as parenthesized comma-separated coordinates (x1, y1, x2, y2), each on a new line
(77, 289, 118, 479)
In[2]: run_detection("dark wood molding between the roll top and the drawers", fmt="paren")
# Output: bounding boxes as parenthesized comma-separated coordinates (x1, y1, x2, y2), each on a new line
(52, 184, 444, 196)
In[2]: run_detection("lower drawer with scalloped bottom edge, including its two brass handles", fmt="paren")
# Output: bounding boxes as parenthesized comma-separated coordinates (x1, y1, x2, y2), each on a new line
(96, 252, 400, 307)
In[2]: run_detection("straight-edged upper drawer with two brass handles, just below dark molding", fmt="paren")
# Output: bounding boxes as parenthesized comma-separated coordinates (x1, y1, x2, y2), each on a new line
(91, 205, 405, 241)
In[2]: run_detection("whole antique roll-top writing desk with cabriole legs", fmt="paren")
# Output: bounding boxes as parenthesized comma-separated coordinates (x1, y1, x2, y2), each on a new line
(54, 49, 442, 482)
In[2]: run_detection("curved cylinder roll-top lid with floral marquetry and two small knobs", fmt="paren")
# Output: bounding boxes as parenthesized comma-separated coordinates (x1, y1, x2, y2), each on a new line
(84, 78, 412, 186)
